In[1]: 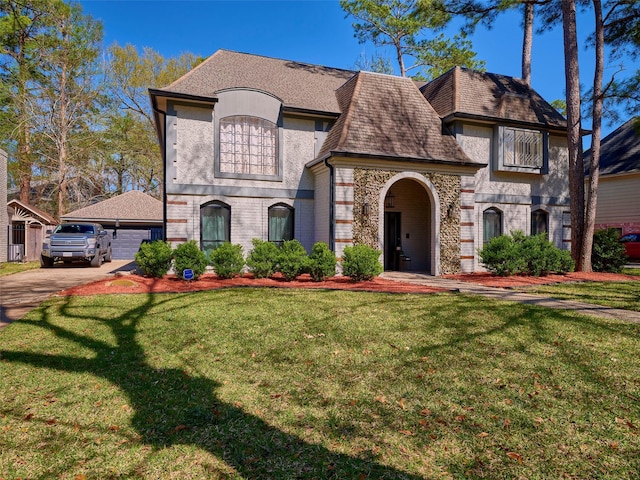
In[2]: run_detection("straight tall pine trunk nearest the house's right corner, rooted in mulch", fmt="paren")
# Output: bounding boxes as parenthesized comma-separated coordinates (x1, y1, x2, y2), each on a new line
(562, 0, 585, 271)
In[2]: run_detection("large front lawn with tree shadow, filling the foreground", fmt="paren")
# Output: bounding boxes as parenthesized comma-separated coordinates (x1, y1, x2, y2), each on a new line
(0, 288, 640, 479)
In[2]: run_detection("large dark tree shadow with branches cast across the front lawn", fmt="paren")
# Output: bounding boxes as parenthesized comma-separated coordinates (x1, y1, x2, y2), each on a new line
(0, 295, 421, 480)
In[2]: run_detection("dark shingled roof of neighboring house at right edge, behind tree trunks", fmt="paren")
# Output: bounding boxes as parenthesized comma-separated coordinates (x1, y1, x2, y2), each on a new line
(585, 117, 640, 175)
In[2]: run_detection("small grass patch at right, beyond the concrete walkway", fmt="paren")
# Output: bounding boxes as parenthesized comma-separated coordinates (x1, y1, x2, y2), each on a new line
(522, 281, 640, 312)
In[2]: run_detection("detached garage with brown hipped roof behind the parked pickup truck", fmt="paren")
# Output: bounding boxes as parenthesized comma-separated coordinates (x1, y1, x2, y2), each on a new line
(60, 190, 162, 260)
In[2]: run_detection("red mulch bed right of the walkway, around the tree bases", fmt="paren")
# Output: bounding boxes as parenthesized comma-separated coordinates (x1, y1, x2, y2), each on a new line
(443, 272, 640, 288)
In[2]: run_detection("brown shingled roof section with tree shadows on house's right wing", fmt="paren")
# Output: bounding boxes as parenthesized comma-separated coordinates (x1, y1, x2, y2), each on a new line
(422, 67, 567, 129)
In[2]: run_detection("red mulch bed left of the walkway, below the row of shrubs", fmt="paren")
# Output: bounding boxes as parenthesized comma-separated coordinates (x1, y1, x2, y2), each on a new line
(58, 274, 447, 295)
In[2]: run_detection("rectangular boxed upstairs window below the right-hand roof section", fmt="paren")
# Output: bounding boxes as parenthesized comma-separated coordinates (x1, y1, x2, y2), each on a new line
(498, 127, 547, 173)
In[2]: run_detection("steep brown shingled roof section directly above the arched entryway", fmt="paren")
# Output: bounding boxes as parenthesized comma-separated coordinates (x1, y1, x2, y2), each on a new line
(319, 72, 475, 164)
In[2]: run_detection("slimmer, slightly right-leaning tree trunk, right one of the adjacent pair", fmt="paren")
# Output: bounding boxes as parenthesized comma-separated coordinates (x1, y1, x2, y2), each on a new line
(582, 0, 604, 272)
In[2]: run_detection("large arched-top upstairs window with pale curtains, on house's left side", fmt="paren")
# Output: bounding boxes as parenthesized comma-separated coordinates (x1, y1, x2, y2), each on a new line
(220, 115, 278, 175)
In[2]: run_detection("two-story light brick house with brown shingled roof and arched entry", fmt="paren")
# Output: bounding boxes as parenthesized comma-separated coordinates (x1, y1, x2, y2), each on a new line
(150, 50, 569, 275)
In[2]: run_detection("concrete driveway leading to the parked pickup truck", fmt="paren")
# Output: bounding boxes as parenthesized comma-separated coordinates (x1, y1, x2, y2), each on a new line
(0, 260, 135, 328)
